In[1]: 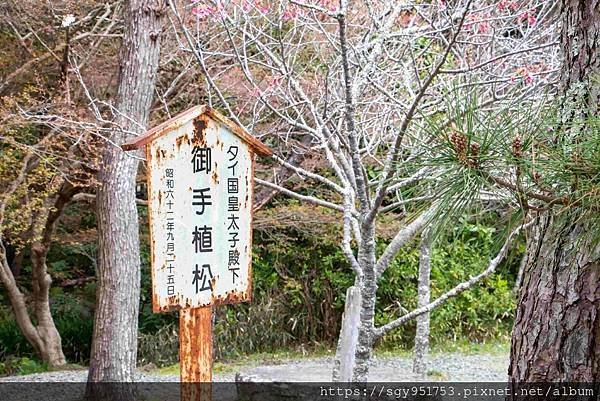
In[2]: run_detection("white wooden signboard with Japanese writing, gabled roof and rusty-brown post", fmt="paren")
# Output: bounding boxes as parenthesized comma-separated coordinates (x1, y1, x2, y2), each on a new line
(122, 106, 272, 399)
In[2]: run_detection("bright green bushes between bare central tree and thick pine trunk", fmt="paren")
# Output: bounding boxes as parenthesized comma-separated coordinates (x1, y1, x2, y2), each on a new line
(376, 216, 516, 347)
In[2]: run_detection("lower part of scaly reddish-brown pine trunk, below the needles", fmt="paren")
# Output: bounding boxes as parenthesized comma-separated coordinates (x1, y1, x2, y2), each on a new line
(509, 214, 600, 382)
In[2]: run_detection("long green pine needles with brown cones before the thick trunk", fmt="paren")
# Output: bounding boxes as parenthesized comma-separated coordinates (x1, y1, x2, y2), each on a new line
(414, 84, 600, 241)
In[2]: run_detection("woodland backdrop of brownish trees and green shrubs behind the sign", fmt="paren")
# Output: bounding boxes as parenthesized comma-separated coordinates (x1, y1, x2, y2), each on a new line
(0, 1, 580, 373)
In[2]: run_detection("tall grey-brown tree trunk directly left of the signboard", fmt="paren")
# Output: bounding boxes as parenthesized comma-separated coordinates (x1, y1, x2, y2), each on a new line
(88, 0, 164, 399)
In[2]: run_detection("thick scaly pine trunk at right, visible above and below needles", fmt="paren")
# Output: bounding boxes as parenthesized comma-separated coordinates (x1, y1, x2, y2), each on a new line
(509, 0, 600, 382)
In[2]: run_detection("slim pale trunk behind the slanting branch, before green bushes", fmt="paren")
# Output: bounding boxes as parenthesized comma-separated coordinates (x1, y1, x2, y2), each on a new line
(413, 229, 432, 376)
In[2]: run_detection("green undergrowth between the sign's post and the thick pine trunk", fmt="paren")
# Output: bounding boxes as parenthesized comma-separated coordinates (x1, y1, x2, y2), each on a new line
(215, 208, 518, 357)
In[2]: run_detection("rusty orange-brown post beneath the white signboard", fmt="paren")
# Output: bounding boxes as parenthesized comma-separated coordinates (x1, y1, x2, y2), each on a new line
(179, 306, 212, 401)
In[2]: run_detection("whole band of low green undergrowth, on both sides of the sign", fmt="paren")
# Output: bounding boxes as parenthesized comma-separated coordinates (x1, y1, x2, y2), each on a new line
(0, 203, 522, 366)
